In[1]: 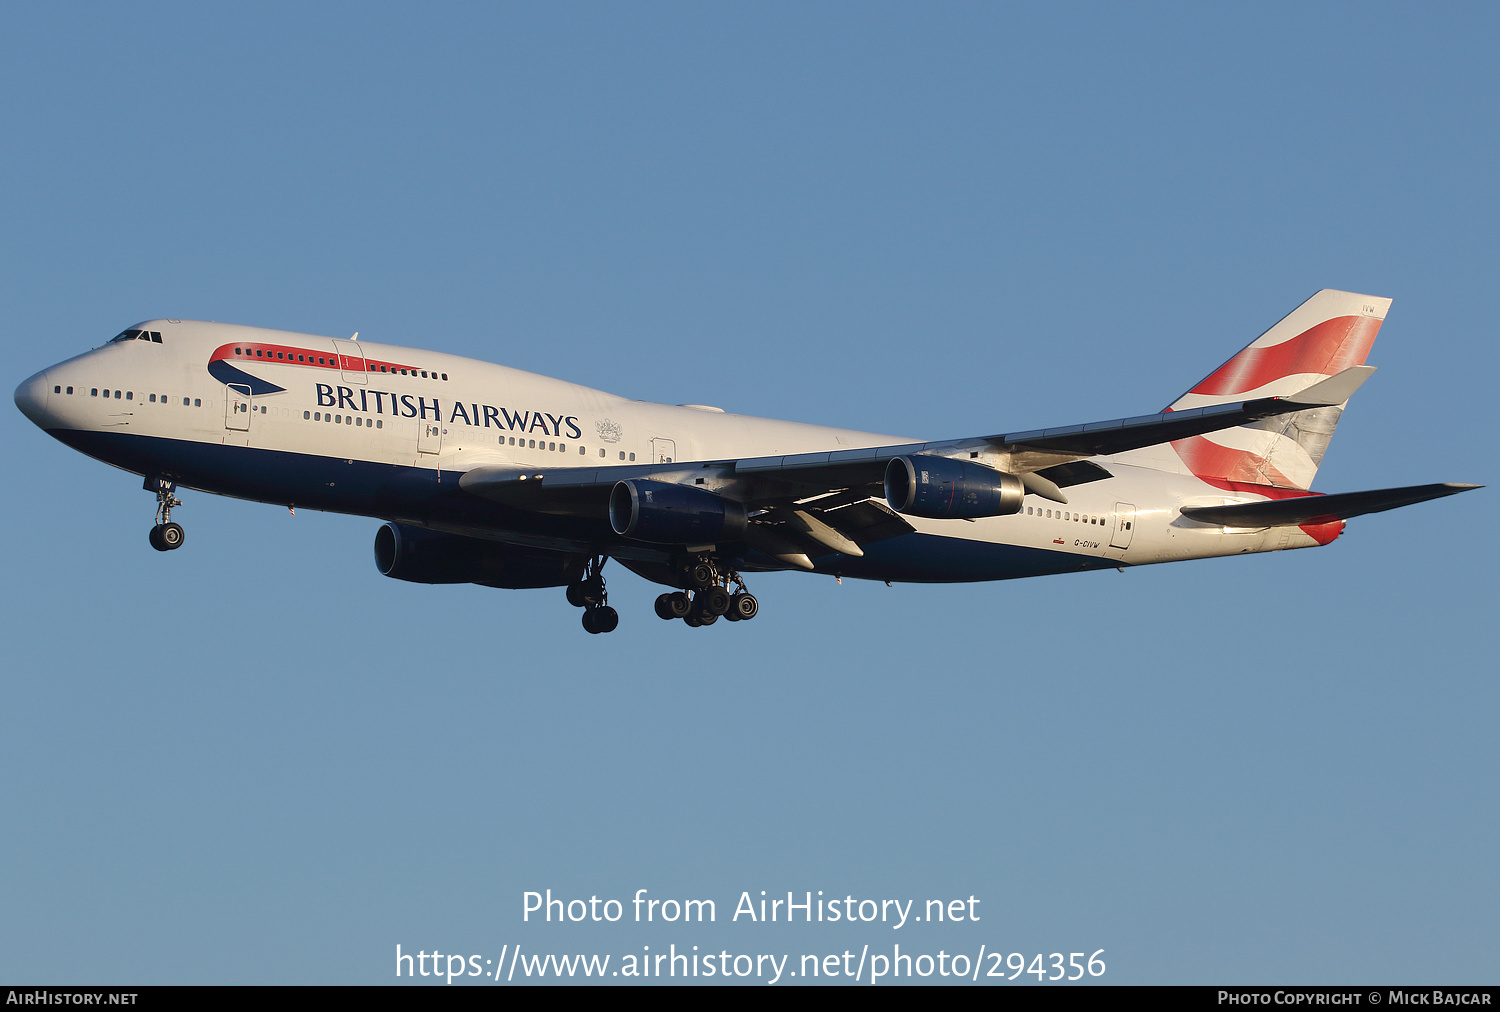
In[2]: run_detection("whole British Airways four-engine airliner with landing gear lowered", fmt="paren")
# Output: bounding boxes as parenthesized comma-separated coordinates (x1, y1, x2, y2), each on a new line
(15, 291, 1479, 633)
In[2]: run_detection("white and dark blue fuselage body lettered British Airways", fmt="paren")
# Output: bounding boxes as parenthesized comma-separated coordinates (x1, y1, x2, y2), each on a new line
(8, 321, 1337, 582)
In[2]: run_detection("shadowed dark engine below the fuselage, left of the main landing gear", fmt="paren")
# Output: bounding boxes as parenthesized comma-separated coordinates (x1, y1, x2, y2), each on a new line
(375, 523, 587, 591)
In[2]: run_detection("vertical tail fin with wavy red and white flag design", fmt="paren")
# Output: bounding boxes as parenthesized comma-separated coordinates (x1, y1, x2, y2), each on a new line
(1167, 289, 1391, 489)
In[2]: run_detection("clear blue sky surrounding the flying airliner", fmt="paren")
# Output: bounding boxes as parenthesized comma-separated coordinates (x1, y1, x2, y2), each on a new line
(0, 3, 1500, 984)
